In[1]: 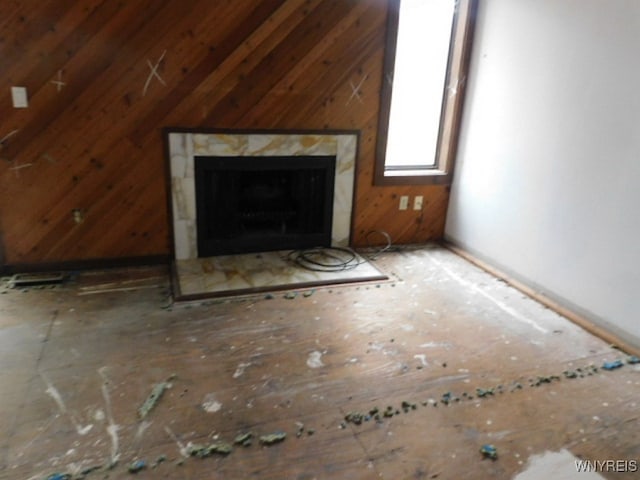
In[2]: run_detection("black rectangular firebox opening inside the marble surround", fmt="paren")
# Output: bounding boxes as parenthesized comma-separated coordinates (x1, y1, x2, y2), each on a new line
(194, 156, 336, 257)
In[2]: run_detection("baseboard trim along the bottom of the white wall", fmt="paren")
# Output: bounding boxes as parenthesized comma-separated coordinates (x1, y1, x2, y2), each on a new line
(441, 239, 640, 356)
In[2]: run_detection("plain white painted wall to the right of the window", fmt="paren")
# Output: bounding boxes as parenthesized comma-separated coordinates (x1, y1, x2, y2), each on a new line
(446, 0, 640, 345)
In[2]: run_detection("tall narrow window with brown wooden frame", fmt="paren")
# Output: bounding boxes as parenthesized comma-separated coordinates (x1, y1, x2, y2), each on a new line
(375, 0, 477, 185)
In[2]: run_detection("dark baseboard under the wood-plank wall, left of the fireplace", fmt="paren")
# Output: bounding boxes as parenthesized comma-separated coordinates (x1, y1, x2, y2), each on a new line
(0, 255, 171, 275)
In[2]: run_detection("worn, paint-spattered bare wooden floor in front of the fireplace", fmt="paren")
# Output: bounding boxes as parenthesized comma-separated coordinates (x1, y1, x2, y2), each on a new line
(0, 246, 640, 480)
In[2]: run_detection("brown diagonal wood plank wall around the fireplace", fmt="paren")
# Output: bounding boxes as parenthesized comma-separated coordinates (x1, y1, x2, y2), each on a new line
(0, 0, 448, 265)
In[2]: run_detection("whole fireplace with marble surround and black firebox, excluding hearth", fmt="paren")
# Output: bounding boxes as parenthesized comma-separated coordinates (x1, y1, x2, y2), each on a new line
(164, 127, 358, 261)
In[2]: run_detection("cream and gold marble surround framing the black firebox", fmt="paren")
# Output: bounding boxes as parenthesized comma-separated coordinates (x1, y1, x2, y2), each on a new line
(165, 128, 358, 260)
